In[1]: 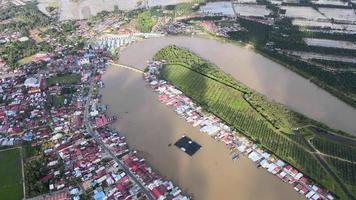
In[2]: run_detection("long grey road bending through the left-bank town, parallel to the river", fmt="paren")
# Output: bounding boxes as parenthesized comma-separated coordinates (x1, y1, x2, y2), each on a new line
(84, 67, 155, 200)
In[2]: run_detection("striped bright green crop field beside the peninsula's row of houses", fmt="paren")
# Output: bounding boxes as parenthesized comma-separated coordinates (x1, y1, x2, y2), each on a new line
(161, 65, 329, 183)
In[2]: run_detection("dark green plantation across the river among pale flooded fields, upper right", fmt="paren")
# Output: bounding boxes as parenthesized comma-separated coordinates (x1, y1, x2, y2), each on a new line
(229, 18, 356, 107)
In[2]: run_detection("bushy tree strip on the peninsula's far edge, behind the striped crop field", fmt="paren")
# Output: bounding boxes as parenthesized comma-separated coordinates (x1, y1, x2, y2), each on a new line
(155, 46, 314, 132)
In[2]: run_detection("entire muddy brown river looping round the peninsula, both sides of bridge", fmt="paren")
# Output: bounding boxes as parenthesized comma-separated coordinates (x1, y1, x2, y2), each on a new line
(101, 37, 356, 200)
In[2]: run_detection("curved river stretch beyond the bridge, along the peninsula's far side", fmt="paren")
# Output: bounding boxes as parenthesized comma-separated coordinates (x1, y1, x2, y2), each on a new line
(120, 36, 356, 136)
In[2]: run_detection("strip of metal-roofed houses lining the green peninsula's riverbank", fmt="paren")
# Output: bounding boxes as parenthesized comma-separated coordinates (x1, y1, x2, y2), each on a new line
(144, 61, 334, 200)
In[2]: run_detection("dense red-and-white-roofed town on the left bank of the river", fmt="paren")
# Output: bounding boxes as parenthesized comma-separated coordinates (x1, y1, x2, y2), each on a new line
(0, 49, 189, 200)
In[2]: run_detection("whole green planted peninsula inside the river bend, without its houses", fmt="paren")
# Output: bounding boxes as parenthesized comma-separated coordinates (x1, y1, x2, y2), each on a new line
(154, 45, 356, 199)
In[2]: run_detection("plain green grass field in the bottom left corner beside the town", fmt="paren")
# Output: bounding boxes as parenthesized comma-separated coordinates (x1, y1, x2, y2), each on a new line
(0, 148, 23, 200)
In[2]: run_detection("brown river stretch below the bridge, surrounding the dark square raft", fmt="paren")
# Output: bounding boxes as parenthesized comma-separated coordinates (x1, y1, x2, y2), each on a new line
(101, 66, 302, 200)
